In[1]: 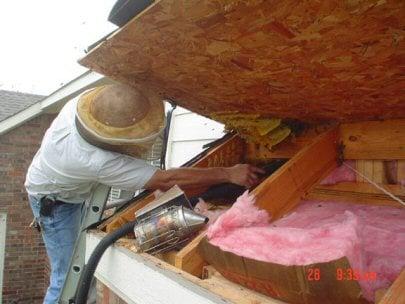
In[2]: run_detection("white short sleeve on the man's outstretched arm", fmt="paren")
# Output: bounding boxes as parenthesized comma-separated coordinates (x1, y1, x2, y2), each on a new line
(97, 151, 159, 191)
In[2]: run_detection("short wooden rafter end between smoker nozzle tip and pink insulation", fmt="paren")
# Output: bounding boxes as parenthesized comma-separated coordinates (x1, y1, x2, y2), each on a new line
(174, 231, 207, 278)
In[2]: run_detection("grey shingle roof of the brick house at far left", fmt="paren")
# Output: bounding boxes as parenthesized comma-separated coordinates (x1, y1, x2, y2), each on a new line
(0, 90, 44, 121)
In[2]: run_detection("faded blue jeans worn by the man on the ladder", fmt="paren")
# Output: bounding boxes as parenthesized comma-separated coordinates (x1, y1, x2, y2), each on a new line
(28, 196, 83, 304)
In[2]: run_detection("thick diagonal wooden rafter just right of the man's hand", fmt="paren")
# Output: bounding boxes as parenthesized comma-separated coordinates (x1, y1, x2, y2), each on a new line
(253, 127, 337, 220)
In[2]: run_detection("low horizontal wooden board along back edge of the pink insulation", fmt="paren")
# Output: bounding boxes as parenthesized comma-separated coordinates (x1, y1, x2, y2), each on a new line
(305, 182, 405, 207)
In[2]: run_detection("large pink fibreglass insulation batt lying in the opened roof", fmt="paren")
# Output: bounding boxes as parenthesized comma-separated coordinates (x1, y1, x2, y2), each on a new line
(207, 192, 405, 301)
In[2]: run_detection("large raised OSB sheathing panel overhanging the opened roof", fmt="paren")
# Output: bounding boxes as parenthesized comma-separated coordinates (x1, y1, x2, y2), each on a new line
(81, 0, 405, 121)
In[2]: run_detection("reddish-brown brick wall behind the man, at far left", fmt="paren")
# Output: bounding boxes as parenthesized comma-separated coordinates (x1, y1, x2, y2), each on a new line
(0, 114, 54, 304)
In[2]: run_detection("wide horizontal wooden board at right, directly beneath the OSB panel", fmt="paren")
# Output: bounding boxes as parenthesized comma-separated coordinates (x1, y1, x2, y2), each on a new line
(340, 120, 405, 160)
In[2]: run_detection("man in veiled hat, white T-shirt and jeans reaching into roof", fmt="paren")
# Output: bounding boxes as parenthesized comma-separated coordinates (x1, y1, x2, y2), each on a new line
(25, 85, 261, 304)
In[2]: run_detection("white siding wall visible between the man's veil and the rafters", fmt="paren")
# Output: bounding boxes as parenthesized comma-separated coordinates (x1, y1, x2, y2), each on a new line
(166, 107, 224, 168)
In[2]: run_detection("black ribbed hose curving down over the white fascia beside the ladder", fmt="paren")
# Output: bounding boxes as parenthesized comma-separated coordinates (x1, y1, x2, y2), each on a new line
(74, 221, 136, 304)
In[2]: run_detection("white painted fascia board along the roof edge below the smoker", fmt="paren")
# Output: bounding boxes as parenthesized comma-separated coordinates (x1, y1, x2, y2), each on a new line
(86, 233, 230, 304)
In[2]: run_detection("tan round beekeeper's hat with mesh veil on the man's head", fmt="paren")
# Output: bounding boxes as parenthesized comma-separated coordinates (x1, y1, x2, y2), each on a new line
(76, 84, 165, 159)
